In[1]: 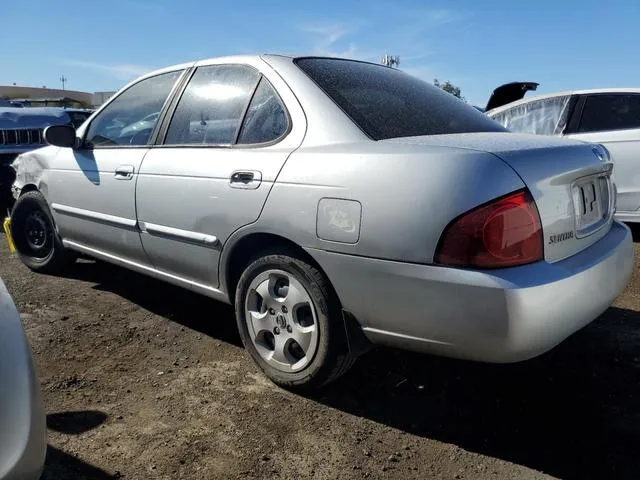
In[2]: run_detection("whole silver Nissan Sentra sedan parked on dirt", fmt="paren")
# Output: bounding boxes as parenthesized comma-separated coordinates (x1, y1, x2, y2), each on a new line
(11, 55, 633, 388)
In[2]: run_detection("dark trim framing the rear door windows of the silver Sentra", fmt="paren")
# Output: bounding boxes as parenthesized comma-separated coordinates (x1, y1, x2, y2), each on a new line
(156, 63, 293, 149)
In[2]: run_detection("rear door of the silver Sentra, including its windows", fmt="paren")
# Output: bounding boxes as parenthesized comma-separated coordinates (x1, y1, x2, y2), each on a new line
(136, 63, 305, 289)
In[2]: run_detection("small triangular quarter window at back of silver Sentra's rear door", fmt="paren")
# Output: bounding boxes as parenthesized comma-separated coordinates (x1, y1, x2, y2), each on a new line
(238, 77, 289, 144)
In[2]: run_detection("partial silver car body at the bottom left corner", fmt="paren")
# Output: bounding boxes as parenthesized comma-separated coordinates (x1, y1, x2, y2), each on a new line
(0, 280, 47, 480)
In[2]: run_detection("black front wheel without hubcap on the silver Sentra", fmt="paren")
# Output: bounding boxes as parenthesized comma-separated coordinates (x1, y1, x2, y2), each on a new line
(11, 191, 75, 272)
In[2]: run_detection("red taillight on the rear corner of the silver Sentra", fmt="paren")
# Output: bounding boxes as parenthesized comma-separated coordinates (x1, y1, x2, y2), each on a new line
(435, 190, 543, 268)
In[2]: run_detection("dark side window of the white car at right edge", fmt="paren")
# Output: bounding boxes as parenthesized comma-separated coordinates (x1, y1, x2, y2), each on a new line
(578, 94, 640, 133)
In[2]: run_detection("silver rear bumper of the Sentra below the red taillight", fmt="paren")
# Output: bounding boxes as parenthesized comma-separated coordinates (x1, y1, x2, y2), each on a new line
(308, 222, 633, 363)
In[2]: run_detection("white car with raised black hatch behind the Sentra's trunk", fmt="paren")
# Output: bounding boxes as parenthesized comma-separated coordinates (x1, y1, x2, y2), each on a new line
(486, 82, 640, 222)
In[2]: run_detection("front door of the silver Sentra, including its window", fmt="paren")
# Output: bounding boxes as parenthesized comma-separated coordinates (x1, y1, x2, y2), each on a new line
(47, 70, 183, 264)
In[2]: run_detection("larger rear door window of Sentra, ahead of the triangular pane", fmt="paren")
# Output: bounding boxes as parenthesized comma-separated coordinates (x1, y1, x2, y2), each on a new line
(164, 65, 260, 145)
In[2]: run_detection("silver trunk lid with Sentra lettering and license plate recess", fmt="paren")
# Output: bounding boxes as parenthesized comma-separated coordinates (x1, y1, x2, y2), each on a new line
(385, 133, 615, 262)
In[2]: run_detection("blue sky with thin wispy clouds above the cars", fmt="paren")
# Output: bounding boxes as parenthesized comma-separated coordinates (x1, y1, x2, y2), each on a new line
(0, 0, 640, 105)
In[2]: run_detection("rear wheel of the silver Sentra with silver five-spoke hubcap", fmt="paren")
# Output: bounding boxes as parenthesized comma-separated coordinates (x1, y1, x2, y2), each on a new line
(235, 253, 354, 388)
